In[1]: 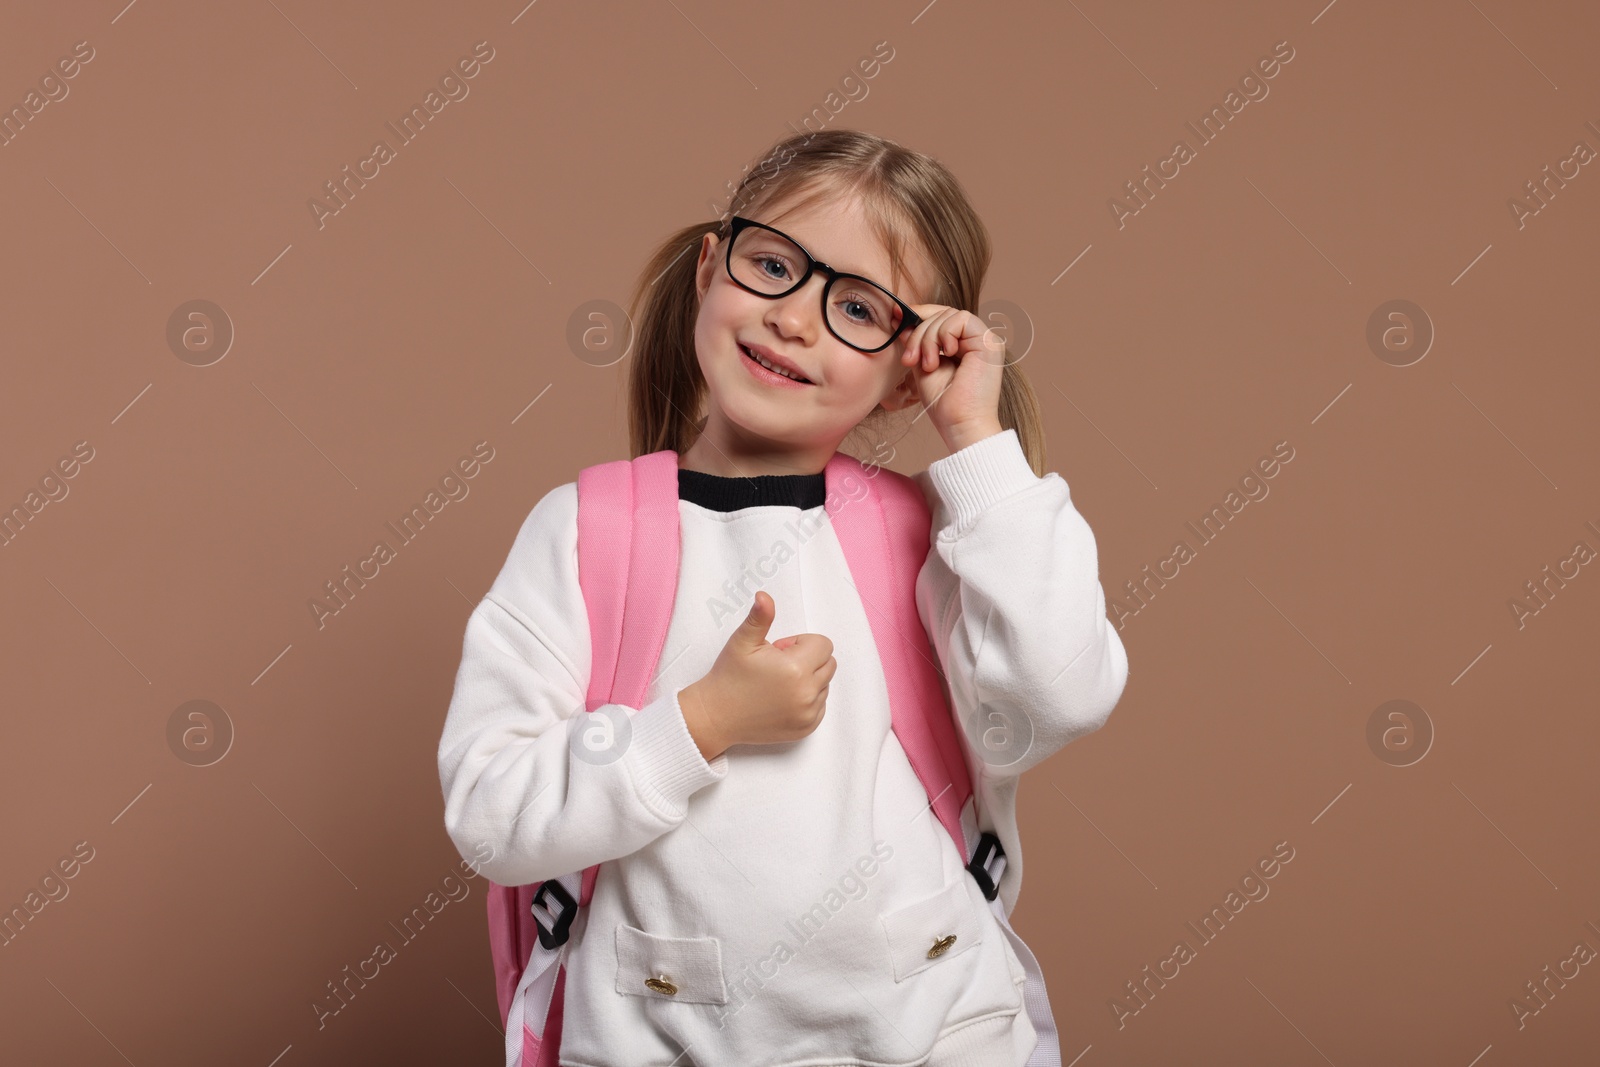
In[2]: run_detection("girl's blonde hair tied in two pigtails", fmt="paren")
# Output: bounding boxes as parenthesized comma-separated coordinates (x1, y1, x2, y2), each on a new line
(627, 130, 1045, 477)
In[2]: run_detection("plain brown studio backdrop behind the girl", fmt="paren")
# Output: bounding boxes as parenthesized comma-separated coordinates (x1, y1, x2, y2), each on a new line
(0, 0, 1600, 1067)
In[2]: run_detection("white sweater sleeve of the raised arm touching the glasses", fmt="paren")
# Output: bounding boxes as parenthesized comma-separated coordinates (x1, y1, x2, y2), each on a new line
(915, 429, 1128, 777)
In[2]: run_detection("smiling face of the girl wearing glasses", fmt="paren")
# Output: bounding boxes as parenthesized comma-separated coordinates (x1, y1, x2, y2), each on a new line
(686, 198, 933, 475)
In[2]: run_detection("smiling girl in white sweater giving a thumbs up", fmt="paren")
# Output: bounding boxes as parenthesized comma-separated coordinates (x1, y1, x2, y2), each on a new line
(438, 130, 1128, 1067)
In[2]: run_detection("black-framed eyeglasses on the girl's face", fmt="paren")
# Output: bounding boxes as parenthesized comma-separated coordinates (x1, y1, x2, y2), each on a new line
(728, 214, 922, 354)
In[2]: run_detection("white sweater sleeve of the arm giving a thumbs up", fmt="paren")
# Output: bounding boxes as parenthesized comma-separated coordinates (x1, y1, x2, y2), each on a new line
(438, 482, 728, 885)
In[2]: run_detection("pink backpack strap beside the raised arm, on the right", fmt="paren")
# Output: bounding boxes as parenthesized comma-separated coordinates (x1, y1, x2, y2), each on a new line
(824, 453, 976, 859)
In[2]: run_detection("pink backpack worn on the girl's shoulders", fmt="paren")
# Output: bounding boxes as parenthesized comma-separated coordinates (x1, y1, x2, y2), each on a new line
(488, 450, 1061, 1067)
